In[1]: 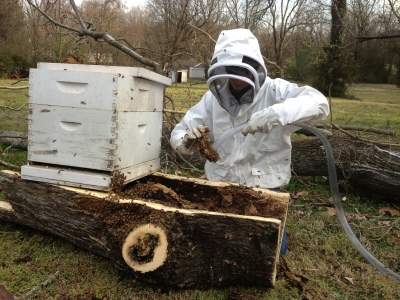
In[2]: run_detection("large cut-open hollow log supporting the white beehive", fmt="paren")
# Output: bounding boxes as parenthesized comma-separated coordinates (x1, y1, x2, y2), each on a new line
(0, 171, 289, 289)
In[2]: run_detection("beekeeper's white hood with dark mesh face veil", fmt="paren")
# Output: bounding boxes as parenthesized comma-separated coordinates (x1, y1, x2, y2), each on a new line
(207, 29, 267, 116)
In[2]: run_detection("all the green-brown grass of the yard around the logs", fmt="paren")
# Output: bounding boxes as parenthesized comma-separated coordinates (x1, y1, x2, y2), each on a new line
(0, 80, 400, 300)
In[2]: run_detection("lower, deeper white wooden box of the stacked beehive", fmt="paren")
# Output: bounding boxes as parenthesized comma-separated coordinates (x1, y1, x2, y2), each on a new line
(28, 104, 162, 171)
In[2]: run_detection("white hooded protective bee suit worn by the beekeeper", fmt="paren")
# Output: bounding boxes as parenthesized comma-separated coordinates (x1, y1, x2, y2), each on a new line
(170, 29, 329, 188)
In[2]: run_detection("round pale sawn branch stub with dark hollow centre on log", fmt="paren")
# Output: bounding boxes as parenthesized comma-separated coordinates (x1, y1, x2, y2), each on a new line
(122, 223, 168, 273)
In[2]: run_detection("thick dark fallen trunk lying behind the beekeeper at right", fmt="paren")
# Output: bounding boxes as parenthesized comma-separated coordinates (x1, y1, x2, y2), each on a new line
(292, 135, 400, 203)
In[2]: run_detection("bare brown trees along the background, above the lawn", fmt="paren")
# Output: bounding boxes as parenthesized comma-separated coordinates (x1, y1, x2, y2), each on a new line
(0, 0, 400, 97)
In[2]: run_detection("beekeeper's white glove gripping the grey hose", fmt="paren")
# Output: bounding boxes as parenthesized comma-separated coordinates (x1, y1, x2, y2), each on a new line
(242, 107, 281, 135)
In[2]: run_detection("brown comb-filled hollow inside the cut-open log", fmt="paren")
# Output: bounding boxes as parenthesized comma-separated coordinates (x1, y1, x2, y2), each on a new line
(117, 175, 287, 220)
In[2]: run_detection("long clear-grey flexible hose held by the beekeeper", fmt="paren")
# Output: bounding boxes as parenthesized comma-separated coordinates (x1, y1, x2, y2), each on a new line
(213, 123, 400, 283)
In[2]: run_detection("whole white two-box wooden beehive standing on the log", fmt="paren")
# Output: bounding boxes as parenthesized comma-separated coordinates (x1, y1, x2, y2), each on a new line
(21, 63, 171, 190)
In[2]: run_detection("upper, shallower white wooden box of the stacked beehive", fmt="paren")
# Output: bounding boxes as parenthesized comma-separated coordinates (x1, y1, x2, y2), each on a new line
(29, 69, 164, 112)
